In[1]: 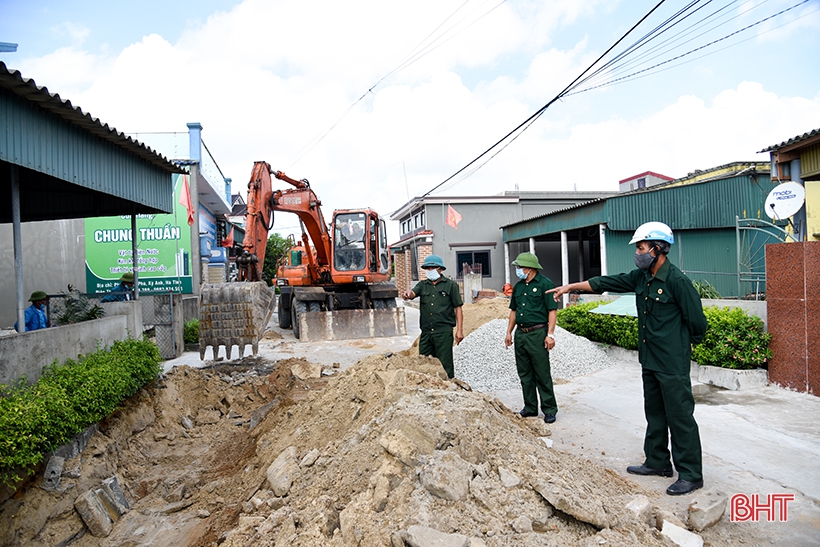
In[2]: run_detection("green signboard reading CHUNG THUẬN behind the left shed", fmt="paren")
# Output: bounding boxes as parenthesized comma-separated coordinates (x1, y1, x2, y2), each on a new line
(85, 175, 193, 294)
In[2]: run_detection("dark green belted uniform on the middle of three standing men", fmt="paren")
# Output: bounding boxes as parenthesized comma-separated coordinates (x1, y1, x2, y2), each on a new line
(510, 273, 558, 416)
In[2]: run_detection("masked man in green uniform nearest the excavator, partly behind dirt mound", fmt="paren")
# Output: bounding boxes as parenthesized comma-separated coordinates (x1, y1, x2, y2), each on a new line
(401, 255, 464, 378)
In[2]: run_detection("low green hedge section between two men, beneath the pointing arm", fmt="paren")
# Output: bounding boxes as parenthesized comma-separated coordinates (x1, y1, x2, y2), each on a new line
(557, 302, 638, 349)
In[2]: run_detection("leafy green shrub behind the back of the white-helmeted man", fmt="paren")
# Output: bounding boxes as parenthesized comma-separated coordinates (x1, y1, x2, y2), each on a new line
(692, 306, 772, 369)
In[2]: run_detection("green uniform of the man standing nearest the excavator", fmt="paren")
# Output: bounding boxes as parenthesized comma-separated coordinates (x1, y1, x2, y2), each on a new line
(413, 275, 464, 378)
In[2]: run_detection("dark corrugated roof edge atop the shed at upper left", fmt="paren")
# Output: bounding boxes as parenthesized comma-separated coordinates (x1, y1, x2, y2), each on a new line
(0, 61, 187, 173)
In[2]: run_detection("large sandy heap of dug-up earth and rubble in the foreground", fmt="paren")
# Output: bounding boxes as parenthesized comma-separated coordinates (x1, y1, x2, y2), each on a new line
(0, 346, 684, 547)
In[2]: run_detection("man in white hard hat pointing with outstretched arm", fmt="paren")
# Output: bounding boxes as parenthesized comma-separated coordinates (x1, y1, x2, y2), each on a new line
(554, 222, 706, 496)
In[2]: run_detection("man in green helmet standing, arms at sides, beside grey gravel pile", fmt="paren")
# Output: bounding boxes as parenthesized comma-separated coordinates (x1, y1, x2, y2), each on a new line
(504, 253, 558, 424)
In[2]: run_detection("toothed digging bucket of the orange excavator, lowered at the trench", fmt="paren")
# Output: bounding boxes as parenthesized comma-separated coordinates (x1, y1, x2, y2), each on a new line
(199, 282, 275, 360)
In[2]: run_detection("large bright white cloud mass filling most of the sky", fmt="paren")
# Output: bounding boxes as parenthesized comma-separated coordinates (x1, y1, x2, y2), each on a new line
(8, 0, 820, 238)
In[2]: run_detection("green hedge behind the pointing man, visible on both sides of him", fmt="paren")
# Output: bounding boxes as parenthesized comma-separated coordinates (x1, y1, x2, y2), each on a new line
(558, 302, 772, 369)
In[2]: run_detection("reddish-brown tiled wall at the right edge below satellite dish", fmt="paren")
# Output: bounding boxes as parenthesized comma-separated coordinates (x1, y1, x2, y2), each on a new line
(766, 241, 820, 396)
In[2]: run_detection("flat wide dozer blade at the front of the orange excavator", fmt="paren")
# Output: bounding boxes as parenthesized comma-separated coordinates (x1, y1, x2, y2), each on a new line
(299, 308, 407, 342)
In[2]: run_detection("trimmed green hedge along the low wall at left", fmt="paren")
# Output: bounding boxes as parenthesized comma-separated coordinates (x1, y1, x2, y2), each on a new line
(0, 338, 162, 486)
